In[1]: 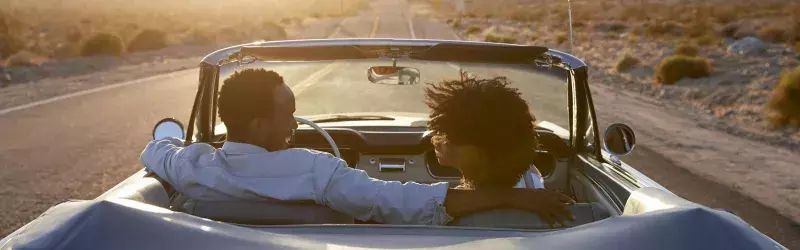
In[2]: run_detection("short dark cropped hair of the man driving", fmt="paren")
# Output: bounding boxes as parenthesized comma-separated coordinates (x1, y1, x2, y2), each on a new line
(218, 69, 283, 132)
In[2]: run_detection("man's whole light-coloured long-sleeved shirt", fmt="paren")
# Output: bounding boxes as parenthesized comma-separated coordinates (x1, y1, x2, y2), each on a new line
(141, 138, 452, 225)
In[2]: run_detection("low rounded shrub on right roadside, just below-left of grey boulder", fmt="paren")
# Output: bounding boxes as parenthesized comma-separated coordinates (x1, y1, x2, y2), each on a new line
(656, 55, 712, 85)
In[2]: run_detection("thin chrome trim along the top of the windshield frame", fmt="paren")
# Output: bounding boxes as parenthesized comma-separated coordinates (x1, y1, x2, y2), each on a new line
(202, 38, 587, 69)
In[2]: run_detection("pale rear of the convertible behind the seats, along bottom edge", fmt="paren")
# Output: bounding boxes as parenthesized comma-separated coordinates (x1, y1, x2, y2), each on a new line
(0, 189, 781, 250)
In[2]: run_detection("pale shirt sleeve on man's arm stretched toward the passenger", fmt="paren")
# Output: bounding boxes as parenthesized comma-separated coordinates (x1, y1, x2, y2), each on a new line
(318, 157, 453, 225)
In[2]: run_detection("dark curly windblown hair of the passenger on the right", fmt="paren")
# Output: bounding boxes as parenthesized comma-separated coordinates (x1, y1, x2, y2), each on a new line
(425, 74, 539, 188)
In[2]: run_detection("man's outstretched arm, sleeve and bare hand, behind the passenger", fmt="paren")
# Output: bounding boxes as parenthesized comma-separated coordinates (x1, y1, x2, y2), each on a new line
(318, 155, 572, 225)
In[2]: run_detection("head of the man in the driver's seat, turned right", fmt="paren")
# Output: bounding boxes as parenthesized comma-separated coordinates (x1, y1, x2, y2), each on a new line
(219, 69, 297, 151)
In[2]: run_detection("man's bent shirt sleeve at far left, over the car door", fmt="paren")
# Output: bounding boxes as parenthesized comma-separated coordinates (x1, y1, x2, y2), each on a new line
(141, 137, 185, 191)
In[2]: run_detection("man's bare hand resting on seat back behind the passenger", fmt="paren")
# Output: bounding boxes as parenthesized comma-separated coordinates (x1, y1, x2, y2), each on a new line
(508, 189, 575, 227)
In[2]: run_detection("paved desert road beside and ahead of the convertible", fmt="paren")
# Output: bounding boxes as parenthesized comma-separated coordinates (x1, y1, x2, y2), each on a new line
(0, 0, 800, 248)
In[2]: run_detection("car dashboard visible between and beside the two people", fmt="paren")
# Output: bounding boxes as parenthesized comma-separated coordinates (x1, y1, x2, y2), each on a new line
(293, 126, 569, 185)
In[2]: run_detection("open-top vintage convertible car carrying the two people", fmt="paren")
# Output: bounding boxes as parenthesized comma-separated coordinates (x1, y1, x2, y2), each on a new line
(0, 39, 785, 249)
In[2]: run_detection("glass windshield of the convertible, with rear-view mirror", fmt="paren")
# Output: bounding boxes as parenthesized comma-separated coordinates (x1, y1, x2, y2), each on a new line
(217, 59, 569, 128)
